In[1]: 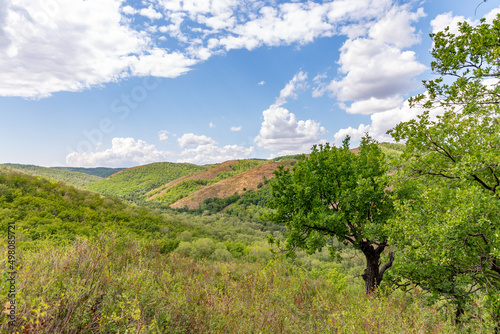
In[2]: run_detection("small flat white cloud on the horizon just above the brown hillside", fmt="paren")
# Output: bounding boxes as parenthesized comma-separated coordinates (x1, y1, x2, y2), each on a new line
(177, 144, 254, 164)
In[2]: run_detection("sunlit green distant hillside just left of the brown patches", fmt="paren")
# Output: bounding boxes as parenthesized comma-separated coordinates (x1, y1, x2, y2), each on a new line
(85, 162, 208, 200)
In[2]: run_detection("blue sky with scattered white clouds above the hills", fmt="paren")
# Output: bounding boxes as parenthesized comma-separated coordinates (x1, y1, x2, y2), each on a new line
(0, 0, 500, 167)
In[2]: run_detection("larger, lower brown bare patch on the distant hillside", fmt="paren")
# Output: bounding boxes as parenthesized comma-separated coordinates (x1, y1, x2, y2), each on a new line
(170, 161, 290, 209)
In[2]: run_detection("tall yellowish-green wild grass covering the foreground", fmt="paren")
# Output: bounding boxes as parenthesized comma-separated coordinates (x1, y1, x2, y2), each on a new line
(0, 236, 488, 334)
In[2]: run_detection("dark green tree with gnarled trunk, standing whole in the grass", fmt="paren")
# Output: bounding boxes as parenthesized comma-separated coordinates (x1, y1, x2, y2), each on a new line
(267, 136, 392, 293)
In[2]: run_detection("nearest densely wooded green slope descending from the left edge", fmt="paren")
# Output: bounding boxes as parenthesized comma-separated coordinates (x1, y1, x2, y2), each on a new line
(0, 169, 176, 244)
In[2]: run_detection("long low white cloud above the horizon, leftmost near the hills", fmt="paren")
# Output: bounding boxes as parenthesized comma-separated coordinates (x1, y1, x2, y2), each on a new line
(66, 138, 172, 167)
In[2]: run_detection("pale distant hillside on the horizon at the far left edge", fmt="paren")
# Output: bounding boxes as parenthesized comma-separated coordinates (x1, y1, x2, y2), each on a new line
(0, 164, 102, 187)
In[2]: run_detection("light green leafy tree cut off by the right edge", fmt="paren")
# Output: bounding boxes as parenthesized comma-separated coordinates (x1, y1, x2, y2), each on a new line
(388, 18, 500, 328)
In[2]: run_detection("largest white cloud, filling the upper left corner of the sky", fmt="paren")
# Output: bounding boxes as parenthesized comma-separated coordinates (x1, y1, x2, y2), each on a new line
(0, 0, 200, 98)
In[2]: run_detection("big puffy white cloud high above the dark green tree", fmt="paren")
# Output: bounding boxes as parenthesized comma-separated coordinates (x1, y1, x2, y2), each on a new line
(328, 7, 426, 114)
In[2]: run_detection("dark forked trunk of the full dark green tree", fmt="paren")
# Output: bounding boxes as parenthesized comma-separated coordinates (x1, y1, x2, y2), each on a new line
(361, 242, 394, 295)
